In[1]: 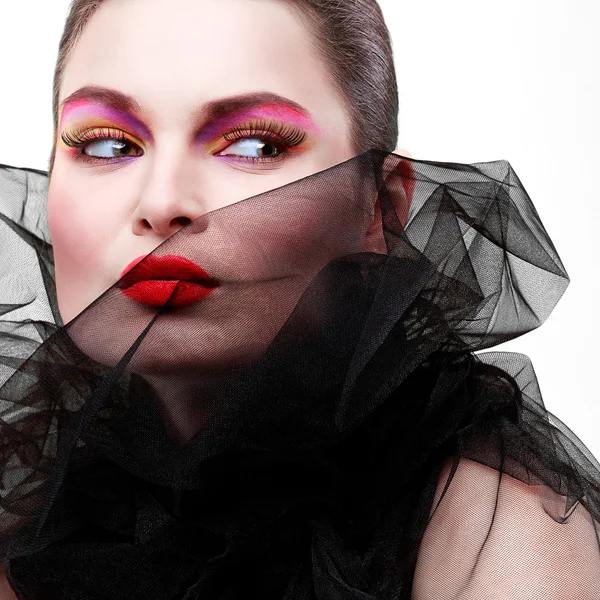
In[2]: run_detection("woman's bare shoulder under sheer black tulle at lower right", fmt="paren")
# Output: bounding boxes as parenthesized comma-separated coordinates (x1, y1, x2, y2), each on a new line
(412, 457, 600, 600)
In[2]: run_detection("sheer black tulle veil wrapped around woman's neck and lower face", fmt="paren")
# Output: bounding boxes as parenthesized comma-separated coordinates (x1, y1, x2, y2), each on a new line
(0, 150, 600, 600)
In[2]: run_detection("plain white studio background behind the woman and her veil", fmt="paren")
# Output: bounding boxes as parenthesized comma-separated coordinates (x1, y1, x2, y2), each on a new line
(0, 0, 600, 458)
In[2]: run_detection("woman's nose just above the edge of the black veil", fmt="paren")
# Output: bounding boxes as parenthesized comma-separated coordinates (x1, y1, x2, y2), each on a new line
(132, 154, 205, 238)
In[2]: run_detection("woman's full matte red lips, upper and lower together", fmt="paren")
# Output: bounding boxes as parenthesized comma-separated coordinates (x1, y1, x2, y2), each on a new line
(118, 254, 219, 307)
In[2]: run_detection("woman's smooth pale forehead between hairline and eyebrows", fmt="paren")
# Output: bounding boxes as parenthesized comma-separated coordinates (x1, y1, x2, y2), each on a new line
(60, 0, 341, 131)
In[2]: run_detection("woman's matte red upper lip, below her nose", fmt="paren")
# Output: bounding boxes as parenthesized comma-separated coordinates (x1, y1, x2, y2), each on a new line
(119, 254, 218, 288)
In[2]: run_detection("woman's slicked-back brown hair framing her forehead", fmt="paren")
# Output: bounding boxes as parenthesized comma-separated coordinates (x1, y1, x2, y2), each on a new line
(49, 0, 398, 174)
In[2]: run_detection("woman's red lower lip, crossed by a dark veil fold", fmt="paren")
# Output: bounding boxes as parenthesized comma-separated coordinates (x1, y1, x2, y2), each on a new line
(121, 279, 216, 307)
